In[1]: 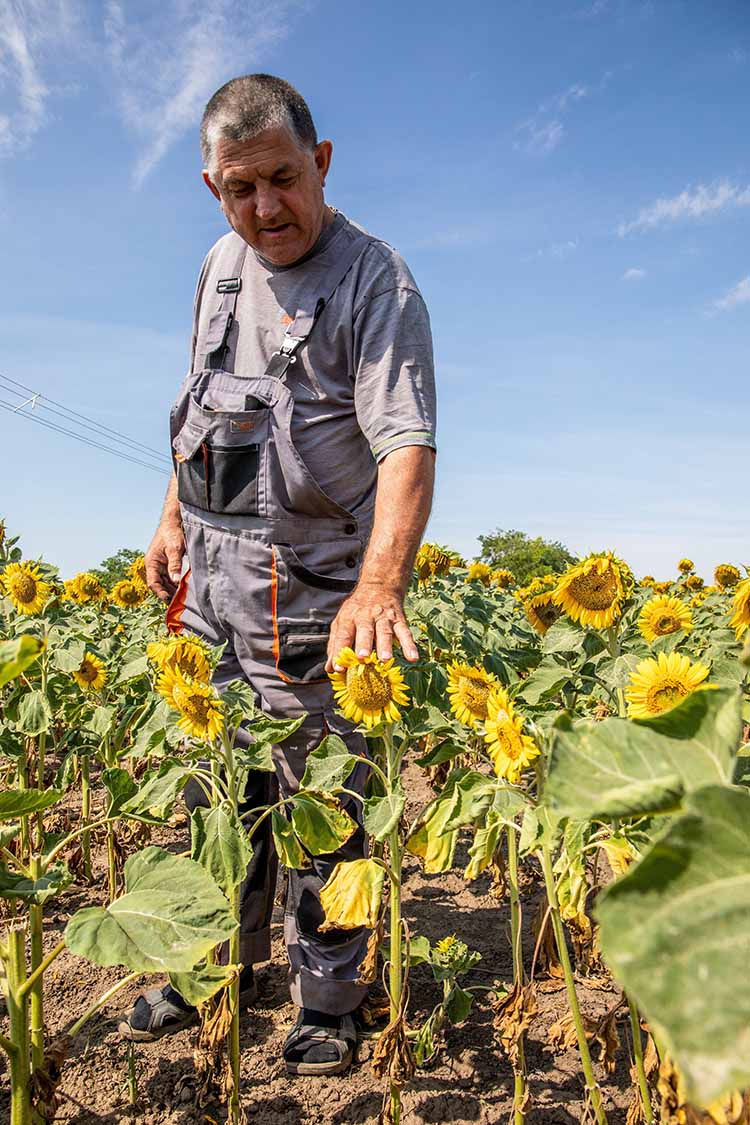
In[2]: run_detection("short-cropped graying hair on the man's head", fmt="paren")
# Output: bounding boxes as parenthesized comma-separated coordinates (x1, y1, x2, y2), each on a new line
(200, 74, 318, 171)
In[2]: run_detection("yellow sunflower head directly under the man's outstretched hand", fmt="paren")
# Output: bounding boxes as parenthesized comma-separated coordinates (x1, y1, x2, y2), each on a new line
(328, 648, 409, 727)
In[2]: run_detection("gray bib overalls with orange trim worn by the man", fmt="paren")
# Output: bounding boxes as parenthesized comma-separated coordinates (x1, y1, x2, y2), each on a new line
(168, 235, 372, 1015)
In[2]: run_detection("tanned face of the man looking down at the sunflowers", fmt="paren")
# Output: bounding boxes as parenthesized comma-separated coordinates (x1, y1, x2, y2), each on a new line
(204, 128, 333, 266)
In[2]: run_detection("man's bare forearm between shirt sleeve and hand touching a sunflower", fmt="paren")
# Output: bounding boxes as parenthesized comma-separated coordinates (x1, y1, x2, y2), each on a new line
(358, 446, 435, 597)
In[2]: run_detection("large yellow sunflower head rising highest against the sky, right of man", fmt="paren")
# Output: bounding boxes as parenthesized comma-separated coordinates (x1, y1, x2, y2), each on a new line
(554, 551, 635, 629)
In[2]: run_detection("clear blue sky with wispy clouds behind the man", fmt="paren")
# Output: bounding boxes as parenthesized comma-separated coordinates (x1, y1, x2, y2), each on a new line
(0, 0, 750, 577)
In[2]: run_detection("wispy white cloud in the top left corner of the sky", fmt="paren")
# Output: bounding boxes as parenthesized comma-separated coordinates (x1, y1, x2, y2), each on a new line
(0, 0, 81, 156)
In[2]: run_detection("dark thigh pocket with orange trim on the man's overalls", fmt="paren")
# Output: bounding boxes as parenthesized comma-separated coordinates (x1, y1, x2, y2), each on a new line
(271, 541, 356, 684)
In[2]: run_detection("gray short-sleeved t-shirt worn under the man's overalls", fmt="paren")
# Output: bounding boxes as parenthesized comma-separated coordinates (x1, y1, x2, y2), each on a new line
(191, 213, 435, 512)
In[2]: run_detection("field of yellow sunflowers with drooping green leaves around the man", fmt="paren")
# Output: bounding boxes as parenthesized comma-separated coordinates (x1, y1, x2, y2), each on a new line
(0, 525, 750, 1125)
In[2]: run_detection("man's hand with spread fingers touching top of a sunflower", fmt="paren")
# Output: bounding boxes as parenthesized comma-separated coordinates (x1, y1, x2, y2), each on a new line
(326, 582, 419, 672)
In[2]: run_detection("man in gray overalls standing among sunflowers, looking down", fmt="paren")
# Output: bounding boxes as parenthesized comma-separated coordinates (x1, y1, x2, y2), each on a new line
(120, 74, 435, 1074)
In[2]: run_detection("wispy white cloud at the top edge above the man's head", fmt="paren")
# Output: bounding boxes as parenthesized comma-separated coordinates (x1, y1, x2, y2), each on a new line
(105, 0, 300, 187)
